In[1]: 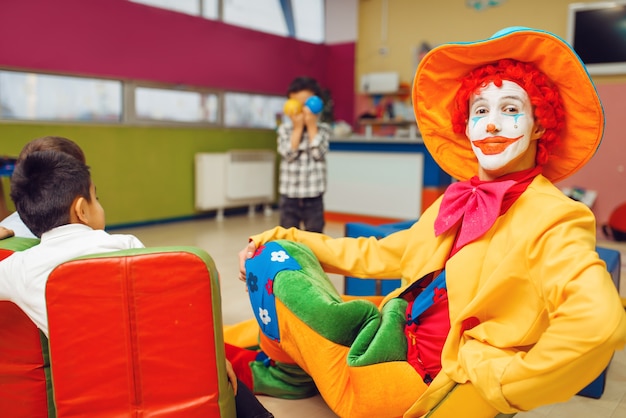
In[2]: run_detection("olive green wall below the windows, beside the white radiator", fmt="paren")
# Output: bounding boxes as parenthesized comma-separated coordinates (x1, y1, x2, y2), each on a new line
(0, 123, 276, 226)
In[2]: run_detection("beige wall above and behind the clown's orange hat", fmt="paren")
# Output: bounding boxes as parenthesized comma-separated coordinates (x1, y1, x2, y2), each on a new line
(355, 0, 626, 86)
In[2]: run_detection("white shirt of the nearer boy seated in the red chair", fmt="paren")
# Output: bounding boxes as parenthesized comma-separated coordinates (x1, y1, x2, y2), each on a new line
(0, 224, 144, 336)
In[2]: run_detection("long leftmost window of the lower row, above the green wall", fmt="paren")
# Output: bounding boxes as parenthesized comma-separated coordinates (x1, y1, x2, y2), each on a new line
(0, 71, 122, 122)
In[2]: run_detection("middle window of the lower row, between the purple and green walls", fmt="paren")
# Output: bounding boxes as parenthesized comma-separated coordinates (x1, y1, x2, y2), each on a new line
(134, 87, 219, 123)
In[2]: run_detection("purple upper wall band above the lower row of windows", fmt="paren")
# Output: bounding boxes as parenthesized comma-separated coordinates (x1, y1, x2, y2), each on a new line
(0, 0, 355, 121)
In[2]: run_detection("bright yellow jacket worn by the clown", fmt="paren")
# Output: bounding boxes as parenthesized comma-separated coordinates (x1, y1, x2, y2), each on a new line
(252, 176, 626, 416)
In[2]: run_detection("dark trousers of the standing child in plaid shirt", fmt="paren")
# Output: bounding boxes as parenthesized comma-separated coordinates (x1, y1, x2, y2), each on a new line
(279, 195, 324, 232)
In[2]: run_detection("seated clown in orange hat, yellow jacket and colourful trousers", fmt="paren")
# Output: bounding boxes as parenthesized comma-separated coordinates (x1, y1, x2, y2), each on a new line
(228, 28, 626, 417)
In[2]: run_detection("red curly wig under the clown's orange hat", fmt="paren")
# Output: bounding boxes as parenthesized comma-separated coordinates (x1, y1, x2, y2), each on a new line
(452, 59, 565, 165)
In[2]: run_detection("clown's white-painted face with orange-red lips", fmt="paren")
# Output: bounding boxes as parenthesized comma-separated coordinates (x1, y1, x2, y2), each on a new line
(466, 80, 543, 176)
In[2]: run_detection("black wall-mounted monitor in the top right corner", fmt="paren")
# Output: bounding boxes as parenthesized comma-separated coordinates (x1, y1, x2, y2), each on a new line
(567, 0, 626, 75)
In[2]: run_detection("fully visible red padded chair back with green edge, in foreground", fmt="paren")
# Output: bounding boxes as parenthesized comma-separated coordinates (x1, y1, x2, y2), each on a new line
(46, 249, 233, 418)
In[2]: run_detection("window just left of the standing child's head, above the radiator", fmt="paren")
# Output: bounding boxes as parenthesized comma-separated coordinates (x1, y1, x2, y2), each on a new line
(224, 93, 285, 129)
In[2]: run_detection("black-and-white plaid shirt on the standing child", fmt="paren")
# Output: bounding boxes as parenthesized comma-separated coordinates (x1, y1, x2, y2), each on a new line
(277, 123, 331, 198)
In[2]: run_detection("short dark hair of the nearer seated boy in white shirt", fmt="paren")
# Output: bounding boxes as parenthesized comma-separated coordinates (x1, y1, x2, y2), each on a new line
(11, 150, 91, 238)
